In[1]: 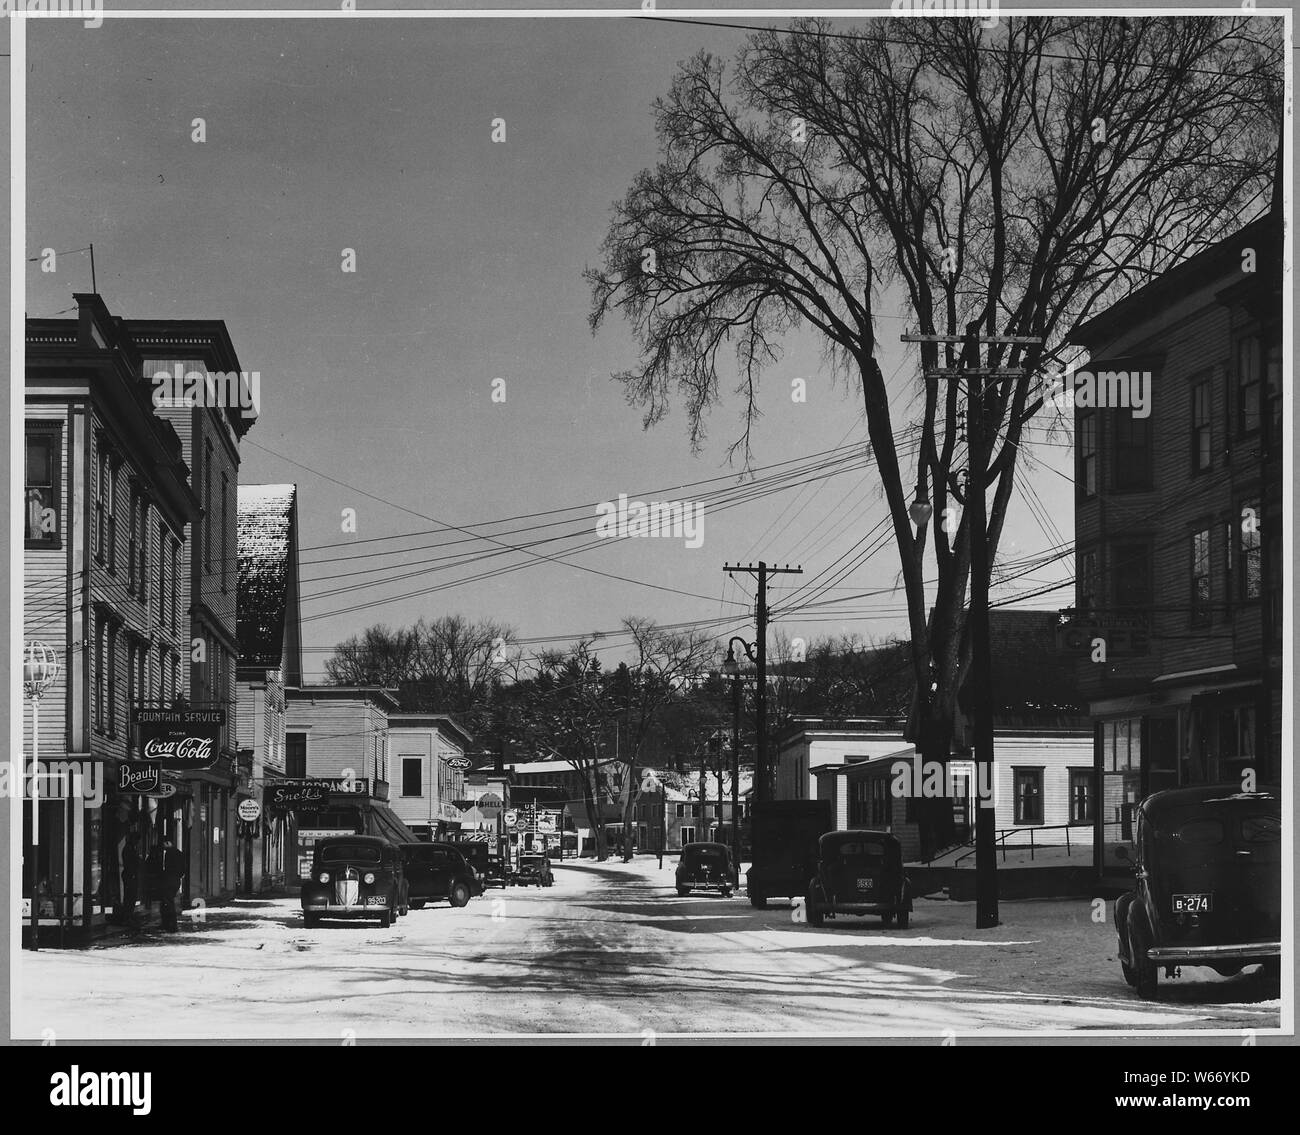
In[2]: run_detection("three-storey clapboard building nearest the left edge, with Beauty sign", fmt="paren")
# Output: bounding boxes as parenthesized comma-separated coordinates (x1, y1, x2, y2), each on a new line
(23, 295, 202, 940)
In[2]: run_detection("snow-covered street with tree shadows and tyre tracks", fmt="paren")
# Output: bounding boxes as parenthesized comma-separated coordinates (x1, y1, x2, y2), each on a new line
(13, 858, 1281, 1043)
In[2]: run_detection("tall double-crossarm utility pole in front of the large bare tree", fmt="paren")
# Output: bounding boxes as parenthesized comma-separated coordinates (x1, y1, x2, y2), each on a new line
(902, 332, 1043, 930)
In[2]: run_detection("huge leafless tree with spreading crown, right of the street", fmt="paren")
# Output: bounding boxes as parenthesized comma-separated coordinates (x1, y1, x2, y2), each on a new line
(588, 17, 1282, 841)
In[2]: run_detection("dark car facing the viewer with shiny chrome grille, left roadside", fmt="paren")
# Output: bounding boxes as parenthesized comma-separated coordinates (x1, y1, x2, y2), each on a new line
(300, 835, 408, 927)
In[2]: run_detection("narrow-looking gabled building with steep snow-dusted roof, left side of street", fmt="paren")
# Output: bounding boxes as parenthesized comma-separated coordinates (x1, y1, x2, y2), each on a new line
(235, 485, 303, 894)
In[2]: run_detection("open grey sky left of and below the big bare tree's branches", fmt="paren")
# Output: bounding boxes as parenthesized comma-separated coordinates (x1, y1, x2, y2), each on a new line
(26, 18, 1073, 676)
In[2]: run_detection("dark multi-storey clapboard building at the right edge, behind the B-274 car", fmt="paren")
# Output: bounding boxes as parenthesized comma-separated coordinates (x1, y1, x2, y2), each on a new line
(1061, 209, 1283, 870)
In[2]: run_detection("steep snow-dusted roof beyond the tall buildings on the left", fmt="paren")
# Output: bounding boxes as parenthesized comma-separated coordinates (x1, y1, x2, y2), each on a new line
(237, 485, 298, 670)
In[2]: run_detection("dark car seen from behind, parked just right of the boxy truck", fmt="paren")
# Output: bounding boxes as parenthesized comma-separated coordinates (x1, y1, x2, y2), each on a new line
(803, 831, 911, 930)
